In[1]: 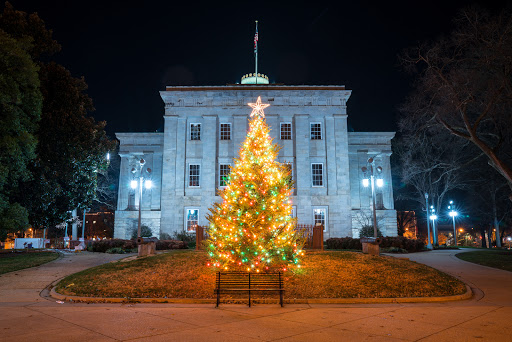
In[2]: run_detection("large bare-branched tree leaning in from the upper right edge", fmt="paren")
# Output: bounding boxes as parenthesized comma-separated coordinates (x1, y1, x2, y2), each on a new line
(402, 8, 512, 201)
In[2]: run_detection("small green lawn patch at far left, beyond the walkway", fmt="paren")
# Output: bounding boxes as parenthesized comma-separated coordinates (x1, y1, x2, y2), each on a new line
(0, 252, 59, 274)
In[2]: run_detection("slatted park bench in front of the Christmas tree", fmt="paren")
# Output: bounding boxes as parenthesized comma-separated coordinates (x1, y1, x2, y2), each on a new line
(215, 272, 284, 307)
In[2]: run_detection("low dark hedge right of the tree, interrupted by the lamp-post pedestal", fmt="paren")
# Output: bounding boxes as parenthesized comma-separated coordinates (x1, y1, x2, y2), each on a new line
(325, 236, 425, 253)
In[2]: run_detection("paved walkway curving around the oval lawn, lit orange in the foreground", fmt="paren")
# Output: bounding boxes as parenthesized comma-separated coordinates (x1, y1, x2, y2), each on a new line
(0, 250, 512, 342)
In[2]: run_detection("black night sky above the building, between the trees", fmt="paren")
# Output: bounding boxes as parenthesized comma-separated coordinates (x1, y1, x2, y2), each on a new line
(2, 0, 510, 136)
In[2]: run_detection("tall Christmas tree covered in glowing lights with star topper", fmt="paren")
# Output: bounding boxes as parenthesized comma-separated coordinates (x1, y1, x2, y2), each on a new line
(206, 97, 304, 272)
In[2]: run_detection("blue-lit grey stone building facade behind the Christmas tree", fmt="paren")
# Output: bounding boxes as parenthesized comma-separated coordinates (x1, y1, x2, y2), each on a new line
(114, 84, 397, 238)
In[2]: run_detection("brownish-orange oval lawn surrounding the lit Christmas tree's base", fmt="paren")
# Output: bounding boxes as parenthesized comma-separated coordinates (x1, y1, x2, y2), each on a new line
(56, 251, 466, 299)
